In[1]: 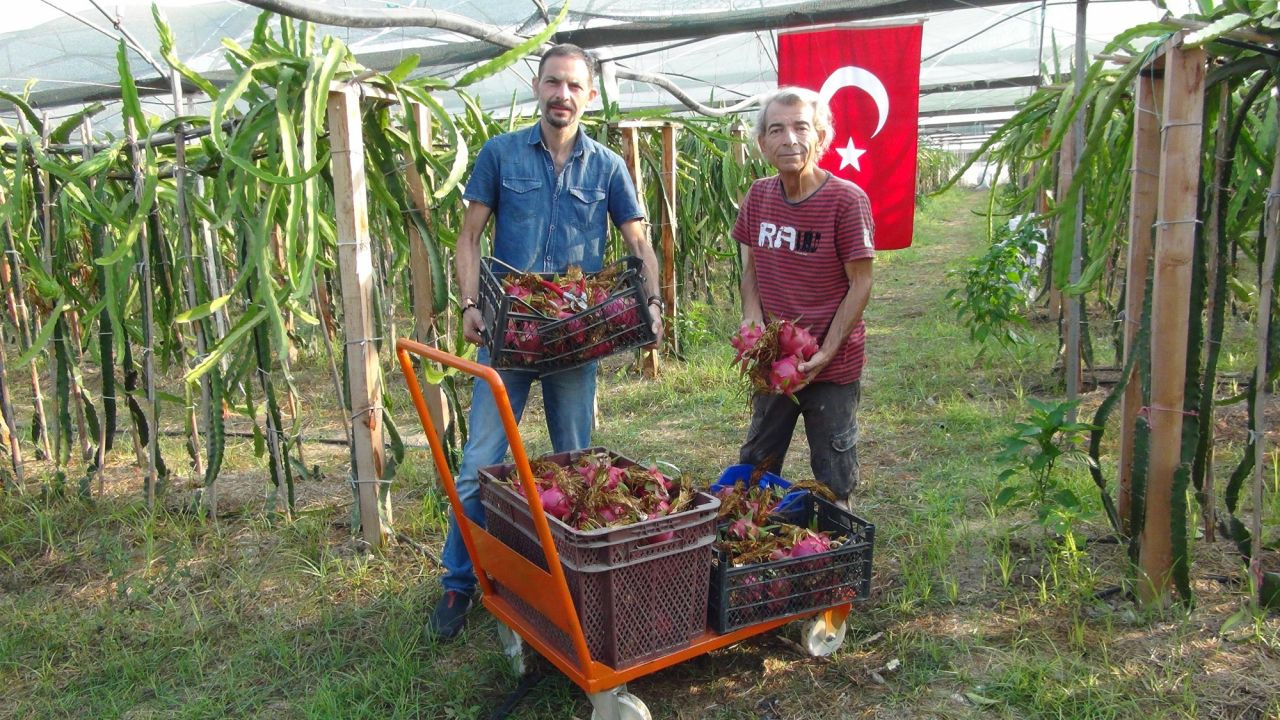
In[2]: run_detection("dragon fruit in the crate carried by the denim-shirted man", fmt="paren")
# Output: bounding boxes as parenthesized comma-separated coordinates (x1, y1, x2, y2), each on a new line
(502, 264, 644, 365)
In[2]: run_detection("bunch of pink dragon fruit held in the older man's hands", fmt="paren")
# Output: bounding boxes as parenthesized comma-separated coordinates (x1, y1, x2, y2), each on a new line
(730, 320, 819, 397)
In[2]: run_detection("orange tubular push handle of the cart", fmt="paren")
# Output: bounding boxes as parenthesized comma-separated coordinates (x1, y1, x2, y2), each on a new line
(396, 338, 591, 671)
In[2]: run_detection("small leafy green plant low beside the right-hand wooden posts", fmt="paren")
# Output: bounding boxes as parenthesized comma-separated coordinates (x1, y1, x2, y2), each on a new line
(993, 398, 1092, 533)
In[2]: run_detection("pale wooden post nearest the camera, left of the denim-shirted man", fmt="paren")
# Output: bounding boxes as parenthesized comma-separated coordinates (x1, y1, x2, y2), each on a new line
(328, 86, 390, 548)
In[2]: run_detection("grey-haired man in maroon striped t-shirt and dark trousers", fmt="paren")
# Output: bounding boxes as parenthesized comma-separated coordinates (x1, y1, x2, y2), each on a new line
(733, 87, 876, 507)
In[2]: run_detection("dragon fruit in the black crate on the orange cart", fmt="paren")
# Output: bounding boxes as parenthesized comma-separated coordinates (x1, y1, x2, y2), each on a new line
(716, 483, 856, 614)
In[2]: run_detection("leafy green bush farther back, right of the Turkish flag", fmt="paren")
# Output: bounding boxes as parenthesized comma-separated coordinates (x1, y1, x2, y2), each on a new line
(946, 219, 1044, 347)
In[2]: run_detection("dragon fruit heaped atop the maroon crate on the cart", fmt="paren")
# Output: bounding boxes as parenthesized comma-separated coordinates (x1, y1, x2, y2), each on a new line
(511, 452, 698, 530)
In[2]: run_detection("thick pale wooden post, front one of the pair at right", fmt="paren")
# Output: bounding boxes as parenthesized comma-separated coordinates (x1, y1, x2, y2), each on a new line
(1138, 33, 1204, 603)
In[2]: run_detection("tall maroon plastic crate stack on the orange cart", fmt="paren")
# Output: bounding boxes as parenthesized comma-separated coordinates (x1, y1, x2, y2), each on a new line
(479, 447, 719, 669)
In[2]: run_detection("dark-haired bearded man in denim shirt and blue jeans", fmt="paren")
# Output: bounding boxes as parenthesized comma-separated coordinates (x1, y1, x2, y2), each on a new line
(426, 45, 662, 641)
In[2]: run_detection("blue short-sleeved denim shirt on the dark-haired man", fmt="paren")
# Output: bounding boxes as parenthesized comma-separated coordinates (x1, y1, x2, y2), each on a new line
(462, 123, 644, 273)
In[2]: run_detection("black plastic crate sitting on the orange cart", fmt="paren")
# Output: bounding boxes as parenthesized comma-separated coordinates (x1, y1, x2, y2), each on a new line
(708, 492, 876, 633)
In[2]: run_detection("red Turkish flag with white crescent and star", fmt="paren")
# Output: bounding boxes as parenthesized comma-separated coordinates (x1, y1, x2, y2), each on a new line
(778, 24, 922, 250)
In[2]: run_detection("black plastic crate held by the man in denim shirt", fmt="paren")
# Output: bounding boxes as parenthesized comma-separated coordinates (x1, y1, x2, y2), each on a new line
(480, 256, 657, 373)
